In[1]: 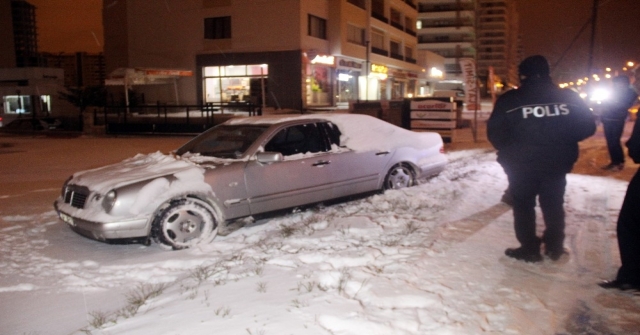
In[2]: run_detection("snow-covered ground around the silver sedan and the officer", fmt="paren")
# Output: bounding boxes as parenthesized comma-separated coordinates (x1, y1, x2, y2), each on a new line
(0, 128, 640, 335)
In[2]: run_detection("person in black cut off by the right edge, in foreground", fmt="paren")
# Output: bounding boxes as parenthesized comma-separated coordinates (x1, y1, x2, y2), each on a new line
(599, 109, 640, 290)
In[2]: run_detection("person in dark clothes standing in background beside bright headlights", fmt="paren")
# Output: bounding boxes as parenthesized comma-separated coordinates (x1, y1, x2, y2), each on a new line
(600, 76, 638, 172)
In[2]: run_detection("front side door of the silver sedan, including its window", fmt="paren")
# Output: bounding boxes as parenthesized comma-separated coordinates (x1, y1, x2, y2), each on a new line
(245, 122, 331, 214)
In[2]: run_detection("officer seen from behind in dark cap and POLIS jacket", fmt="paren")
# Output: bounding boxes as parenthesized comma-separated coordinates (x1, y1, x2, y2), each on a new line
(487, 55, 596, 262)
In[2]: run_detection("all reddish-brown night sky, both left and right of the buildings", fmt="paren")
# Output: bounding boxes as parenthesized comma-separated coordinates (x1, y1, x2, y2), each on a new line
(28, 0, 640, 79)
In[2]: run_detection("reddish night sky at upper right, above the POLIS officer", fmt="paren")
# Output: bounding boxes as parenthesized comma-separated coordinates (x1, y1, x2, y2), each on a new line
(516, 0, 640, 79)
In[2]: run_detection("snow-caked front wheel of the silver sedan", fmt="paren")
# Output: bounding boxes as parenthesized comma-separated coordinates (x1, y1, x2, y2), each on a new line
(153, 198, 218, 250)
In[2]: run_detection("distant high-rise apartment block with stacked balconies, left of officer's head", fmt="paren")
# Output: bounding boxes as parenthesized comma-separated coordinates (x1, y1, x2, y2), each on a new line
(417, 0, 520, 94)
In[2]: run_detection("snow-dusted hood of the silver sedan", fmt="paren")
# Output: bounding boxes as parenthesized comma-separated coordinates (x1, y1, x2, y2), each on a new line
(69, 152, 204, 194)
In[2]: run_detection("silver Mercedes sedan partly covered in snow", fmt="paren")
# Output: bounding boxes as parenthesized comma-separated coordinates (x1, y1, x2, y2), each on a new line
(54, 114, 447, 249)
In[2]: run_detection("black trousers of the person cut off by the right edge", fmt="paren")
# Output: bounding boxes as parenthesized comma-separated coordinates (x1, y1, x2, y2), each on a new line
(616, 170, 640, 285)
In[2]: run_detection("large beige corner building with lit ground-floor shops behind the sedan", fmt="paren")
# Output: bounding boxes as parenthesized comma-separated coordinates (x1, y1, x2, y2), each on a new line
(103, 0, 440, 109)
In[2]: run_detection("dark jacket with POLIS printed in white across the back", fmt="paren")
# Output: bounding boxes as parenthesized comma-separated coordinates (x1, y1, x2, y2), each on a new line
(487, 77, 596, 173)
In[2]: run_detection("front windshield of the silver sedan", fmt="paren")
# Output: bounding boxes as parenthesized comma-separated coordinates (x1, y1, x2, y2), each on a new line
(176, 125, 268, 158)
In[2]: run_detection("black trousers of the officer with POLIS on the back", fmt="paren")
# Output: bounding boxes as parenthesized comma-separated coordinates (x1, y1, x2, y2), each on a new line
(507, 168, 567, 252)
